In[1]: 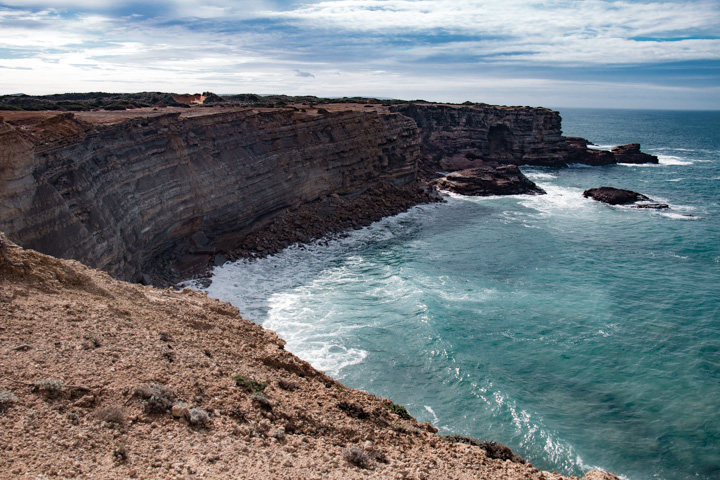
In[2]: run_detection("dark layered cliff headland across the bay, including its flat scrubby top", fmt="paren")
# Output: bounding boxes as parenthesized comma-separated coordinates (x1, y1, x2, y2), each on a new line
(0, 92, 657, 285)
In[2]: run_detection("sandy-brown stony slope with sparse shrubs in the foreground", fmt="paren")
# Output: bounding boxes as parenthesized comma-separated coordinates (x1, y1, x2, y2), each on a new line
(0, 237, 615, 480)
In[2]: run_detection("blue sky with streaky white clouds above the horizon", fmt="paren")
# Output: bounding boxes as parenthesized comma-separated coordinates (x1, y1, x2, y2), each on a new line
(0, 0, 720, 110)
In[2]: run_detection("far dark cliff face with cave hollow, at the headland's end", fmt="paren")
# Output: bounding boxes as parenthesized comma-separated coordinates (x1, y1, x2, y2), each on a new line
(392, 104, 567, 176)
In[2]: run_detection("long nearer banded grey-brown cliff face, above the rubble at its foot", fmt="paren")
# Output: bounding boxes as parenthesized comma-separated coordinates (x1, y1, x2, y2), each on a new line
(0, 110, 418, 280)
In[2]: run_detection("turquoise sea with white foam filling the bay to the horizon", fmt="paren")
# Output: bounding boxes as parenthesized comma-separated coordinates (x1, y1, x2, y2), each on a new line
(197, 109, 720, 480)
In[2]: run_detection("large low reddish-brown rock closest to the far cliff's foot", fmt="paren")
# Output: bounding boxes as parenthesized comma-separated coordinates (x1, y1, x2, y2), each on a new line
(434, 165, 545, 196)
